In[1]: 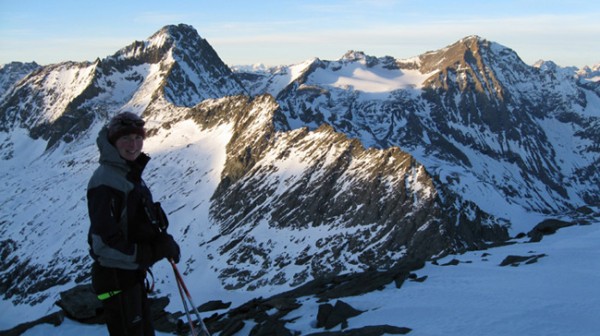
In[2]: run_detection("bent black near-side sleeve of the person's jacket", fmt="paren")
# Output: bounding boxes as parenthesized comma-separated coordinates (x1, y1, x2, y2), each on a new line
(87, 185, 155, 269)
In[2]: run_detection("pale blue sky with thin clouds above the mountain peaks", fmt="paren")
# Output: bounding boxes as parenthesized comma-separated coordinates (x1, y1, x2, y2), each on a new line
(0, 0, 600, 67)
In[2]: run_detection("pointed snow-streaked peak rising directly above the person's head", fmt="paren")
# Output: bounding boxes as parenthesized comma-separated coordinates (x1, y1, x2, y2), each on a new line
(0, 25, 245, 147)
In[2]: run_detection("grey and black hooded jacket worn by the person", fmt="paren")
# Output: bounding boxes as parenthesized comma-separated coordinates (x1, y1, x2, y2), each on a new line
(87, 127, 160, 270)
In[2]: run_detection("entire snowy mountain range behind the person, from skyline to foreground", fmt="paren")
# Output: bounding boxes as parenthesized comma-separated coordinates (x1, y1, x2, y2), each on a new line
(0, 25, 600, 334)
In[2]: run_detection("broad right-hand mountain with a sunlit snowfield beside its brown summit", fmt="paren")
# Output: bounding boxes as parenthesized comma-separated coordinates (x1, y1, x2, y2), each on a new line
(237, 36, 600, 232)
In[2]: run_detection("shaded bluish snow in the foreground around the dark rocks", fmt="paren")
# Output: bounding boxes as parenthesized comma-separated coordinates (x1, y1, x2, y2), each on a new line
(14, 223, 600, 336)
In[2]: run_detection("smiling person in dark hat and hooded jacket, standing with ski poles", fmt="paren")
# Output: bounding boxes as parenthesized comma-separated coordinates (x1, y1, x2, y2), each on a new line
(87, 112, 180, 335)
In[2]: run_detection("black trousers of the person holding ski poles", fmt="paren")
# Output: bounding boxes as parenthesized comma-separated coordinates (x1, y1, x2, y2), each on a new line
(102, 283, 154, 336)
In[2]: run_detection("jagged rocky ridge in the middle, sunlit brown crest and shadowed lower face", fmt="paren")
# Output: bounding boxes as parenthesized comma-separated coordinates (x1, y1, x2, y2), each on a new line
(204, 96, 508, 289)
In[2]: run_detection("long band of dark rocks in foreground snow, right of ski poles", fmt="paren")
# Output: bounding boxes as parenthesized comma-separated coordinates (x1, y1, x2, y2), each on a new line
(205, 261, 423, 336)
